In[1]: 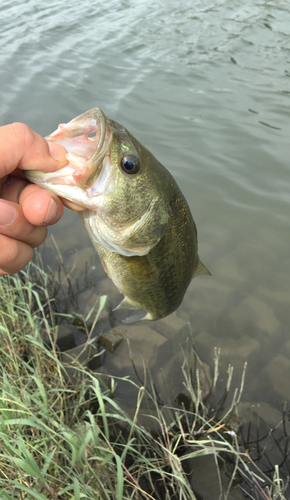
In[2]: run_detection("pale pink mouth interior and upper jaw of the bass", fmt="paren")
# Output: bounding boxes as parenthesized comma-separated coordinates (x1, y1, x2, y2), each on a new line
(45, 108, 112, 189)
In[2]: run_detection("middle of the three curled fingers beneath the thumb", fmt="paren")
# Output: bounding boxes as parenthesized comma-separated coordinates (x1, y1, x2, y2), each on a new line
(0, 199, 47, 247)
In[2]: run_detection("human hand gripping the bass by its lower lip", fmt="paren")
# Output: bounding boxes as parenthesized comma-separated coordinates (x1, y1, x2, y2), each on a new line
(0, 123, 80, 275)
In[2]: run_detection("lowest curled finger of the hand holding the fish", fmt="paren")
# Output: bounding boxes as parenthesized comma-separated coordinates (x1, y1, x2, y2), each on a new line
(0, 234, 33, 275)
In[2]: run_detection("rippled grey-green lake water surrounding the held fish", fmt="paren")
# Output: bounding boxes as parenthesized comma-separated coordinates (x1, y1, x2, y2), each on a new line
(0, 0, 290, 484)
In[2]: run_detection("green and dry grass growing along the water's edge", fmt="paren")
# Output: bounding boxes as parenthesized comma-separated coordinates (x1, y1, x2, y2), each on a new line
(0, 256, 287, 500)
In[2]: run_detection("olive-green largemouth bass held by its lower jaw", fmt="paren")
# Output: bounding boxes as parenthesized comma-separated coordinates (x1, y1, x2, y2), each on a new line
(26, 108, 210, 323)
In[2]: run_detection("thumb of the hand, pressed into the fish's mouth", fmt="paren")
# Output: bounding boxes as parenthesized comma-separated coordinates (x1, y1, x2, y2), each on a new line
(0, 123, 68, 177)
